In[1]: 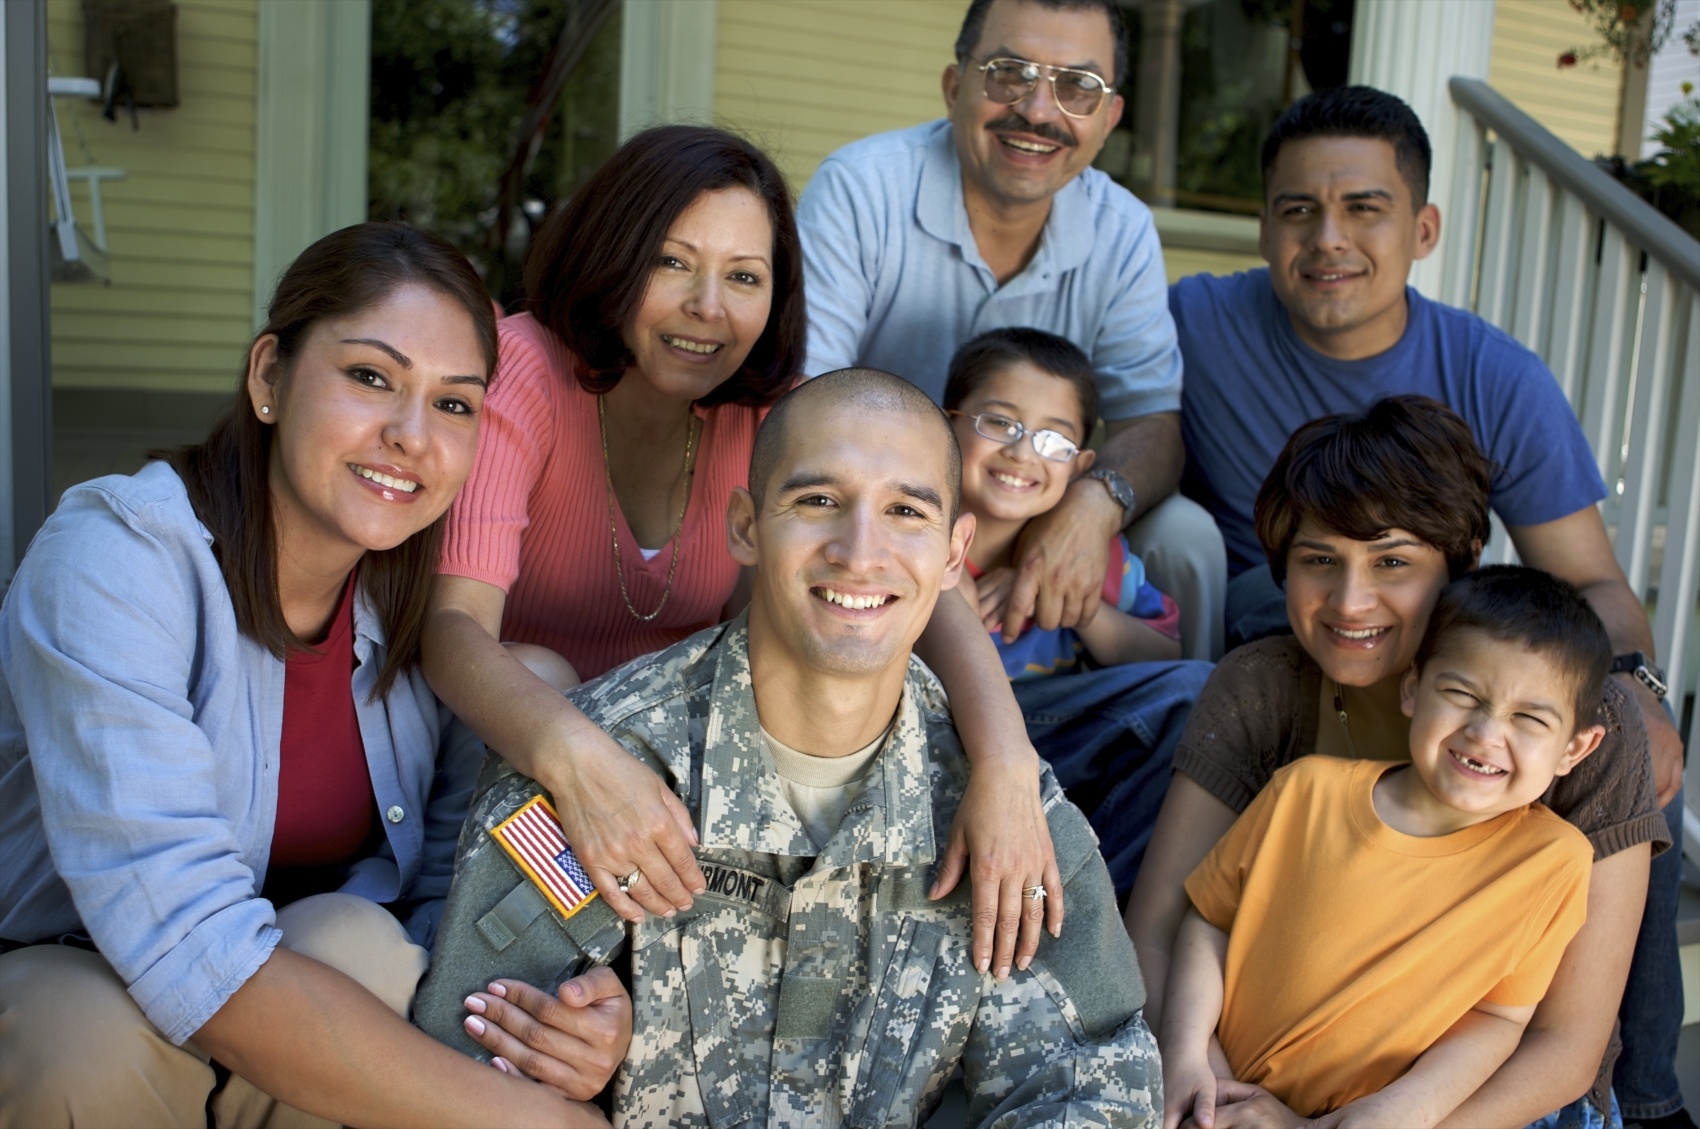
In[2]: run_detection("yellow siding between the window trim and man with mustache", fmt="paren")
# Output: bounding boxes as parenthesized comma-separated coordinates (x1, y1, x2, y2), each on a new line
(714, 0, 967, 192)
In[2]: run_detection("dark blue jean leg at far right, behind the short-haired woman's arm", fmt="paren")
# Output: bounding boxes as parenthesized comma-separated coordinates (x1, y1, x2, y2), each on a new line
(1612, 791, 1683, 1120)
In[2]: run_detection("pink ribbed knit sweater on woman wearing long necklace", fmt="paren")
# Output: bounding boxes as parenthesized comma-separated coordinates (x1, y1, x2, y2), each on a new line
(440, 315, 760, 678)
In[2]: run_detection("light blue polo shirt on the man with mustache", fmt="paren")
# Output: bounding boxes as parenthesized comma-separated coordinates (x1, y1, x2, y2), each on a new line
(797, 119, 1180, 420)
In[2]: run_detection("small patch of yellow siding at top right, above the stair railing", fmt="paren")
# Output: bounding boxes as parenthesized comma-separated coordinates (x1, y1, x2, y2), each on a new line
(1488, 0, 1624, 156)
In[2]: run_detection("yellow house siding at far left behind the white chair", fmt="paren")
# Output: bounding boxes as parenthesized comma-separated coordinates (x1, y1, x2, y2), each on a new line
(48, 0, 258, 393)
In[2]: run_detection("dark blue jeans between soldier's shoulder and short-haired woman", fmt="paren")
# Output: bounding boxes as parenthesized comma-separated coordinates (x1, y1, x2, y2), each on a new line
(1013, 661, 1212, 898)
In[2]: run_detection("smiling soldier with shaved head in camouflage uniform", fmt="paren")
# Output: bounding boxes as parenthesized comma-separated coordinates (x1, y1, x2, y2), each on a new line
(417, 371, 1161, 1129)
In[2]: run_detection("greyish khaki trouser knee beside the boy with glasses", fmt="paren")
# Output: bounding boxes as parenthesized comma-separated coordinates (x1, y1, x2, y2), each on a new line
(1127, 495, 1227, 663)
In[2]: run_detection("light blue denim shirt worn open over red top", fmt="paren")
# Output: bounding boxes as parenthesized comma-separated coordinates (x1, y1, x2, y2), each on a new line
(0, 462, 483, 1042)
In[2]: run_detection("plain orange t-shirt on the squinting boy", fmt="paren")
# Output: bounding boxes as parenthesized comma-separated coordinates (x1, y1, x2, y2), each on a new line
(1187, 757, 1593, 1117)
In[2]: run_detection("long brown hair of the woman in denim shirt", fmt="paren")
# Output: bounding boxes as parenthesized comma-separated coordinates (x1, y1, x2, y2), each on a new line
(160, 223, 496, 699)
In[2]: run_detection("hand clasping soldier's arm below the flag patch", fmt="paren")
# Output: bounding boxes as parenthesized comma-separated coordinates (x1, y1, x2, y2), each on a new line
(464, 967, 632, 1102)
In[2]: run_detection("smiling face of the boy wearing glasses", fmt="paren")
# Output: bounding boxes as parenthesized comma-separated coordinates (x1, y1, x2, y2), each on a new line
(950, 360, 1097, 522)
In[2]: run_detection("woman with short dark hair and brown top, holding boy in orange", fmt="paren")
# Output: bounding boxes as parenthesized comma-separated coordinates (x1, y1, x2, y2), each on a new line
(1127, 396, 1669, 1126)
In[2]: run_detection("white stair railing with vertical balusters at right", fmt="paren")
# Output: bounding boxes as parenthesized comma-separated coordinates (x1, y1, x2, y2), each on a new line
(1443, 78, 1700, 860)
